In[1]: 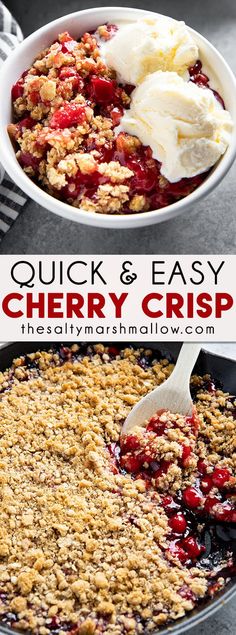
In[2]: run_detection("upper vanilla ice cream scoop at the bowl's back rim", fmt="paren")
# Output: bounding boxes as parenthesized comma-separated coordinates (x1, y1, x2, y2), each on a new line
(102, 16, 198, 85)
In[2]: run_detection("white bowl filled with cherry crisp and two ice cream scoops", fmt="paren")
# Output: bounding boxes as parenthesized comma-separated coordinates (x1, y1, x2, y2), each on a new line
(0, 8, 236, 227)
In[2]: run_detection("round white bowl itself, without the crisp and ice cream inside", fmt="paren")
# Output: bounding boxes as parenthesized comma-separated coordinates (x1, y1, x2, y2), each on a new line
(0, 7, 236, 228)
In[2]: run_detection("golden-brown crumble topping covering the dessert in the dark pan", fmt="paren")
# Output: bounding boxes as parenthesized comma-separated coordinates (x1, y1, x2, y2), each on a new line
(0, 348, 236, 635)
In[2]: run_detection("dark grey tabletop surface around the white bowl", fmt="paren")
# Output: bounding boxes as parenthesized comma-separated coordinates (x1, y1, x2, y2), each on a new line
(0, 0, 236, 254)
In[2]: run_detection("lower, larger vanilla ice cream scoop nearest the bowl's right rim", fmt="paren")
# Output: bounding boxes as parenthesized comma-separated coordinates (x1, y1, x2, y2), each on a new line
(121, 71, 233, 183)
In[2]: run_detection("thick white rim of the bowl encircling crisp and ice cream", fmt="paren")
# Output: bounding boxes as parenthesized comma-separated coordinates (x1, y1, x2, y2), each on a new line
(0, 6, 236, 228)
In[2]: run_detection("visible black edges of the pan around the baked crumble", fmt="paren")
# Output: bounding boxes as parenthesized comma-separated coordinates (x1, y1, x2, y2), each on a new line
(0, 342, 236, 635)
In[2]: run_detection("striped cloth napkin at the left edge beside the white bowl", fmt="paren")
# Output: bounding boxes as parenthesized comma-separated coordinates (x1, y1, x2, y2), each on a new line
(0, 0, 27, 240)
